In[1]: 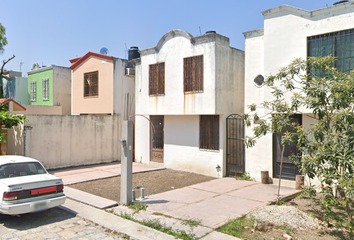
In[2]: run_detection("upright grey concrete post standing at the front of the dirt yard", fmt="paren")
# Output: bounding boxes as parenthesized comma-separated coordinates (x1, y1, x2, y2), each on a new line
(120, 121, 133, 206)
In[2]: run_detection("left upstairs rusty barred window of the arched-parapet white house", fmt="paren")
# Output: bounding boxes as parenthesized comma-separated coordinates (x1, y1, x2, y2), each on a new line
(149, 63, 165, 95)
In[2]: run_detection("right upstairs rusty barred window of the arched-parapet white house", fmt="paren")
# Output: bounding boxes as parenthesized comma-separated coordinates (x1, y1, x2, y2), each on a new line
(183, 55, 203, 92)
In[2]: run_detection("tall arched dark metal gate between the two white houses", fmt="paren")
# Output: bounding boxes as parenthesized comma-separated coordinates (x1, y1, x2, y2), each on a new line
(226, 114, 245, 176)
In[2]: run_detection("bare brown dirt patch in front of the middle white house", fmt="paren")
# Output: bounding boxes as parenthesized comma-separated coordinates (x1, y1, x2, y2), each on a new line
(69, 169, 215, 203)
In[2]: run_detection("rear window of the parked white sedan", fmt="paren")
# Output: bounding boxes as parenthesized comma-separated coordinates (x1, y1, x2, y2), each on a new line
(0, 162, 47, 178)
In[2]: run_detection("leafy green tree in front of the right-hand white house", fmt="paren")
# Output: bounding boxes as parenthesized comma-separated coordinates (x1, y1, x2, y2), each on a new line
(244, 56, 354, 229)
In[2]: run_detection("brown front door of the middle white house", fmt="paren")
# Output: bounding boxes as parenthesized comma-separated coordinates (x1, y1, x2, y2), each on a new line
(150, 116, 164, 163)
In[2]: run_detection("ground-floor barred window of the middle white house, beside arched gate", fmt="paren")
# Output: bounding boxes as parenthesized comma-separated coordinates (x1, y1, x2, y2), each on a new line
(199, 115, 219, 150)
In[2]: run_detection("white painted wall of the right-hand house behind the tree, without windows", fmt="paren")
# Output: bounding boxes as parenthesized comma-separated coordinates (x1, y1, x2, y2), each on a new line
(245, 2, 354, 180)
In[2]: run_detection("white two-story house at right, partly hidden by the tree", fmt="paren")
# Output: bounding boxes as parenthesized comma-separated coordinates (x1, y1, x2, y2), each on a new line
(244, 1, 354, 184)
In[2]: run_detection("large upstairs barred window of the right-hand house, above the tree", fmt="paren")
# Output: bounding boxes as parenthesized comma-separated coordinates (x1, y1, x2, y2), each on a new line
(307, 29, 354, 72)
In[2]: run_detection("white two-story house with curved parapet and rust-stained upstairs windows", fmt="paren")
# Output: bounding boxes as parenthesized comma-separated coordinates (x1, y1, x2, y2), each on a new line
(135, 30, 244, 177)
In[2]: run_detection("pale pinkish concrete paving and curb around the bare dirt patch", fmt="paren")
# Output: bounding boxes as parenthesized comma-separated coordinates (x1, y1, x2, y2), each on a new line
(51, 163, 298, 240)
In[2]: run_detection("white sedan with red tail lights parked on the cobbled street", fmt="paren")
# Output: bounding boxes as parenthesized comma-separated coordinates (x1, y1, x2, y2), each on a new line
(0, 156, 66, 215)
